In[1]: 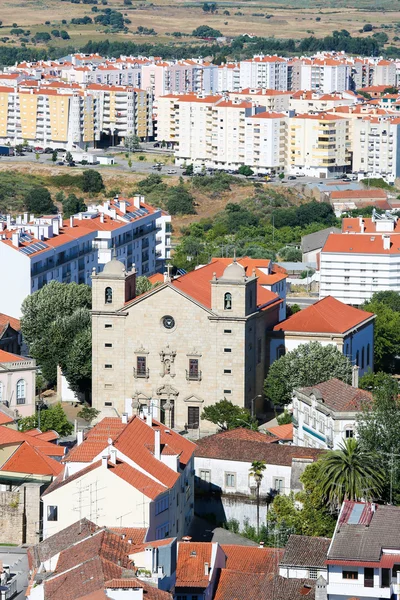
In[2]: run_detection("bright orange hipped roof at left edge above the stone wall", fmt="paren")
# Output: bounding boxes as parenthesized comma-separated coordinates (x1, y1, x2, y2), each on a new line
(0, 442, 63, 477)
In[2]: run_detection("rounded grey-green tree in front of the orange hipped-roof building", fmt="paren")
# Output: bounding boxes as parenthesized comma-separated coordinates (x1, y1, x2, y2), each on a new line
(264, 342, 352, 405)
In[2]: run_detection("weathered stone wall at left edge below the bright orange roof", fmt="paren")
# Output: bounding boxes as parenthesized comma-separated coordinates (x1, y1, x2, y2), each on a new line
(0, 483, 40, 545)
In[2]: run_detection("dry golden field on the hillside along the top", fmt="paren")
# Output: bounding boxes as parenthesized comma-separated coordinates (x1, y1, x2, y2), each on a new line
(0, 0, 400, 49)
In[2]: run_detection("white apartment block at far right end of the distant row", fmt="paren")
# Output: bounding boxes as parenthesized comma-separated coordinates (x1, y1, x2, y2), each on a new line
(352, 115, 400, 183)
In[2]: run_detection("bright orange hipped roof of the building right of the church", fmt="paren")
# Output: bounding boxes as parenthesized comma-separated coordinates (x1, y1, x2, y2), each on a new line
(273, 296, 374, 334)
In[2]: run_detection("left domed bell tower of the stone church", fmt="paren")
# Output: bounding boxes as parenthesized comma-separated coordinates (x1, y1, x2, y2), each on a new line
(92, 258, 136, 312)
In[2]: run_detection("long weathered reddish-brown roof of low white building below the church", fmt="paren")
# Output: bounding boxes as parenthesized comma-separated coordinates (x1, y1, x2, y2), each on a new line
(195, 433, 323, 466)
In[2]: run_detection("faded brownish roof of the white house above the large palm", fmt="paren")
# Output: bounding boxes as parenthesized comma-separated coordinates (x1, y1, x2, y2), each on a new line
(294, 378, 372, 412)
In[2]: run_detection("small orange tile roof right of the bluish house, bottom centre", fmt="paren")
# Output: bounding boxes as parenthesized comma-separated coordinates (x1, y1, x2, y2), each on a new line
(175, 542, 212, 588)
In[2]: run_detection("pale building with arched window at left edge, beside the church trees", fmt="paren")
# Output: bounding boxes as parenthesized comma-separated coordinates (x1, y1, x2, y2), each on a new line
(0, 350, 36, 417)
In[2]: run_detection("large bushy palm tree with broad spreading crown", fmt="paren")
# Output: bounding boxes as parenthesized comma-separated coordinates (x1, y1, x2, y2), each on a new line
(319, 438, 384, 508)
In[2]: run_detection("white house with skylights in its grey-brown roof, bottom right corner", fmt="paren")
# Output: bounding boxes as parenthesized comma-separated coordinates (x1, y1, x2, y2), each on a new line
(326, 500, 400, 600)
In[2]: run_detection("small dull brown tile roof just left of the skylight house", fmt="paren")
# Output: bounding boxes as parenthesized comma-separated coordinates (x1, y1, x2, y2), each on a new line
(280, 535, 331, 568)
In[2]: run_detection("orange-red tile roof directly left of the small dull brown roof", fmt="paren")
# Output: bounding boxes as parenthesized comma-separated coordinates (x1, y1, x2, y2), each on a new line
(221, 544, 284, 574)
